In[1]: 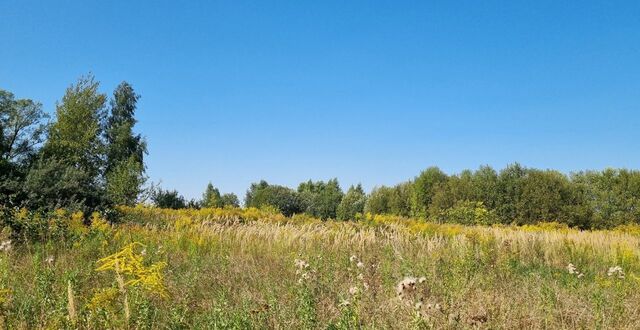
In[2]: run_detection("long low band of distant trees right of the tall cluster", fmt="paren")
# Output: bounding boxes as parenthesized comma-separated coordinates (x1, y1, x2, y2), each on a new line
(156, 163, 640, 229)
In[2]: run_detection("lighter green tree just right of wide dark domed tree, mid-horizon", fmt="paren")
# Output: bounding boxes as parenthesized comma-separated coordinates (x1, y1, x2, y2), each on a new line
(298, 179, 343, 219)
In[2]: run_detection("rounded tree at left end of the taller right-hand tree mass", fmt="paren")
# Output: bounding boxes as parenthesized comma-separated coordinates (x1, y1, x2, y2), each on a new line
(411, 167, 447, 218)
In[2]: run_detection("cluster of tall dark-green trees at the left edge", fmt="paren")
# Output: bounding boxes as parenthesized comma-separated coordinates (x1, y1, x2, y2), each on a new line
(0, 75, 146, 212)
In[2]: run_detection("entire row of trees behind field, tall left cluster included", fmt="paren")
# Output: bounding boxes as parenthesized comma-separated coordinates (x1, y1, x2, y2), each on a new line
(0, 75, 640, 229)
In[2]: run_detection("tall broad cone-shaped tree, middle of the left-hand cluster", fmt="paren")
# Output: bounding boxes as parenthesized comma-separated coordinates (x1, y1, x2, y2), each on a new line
(36, 76, 108, 210)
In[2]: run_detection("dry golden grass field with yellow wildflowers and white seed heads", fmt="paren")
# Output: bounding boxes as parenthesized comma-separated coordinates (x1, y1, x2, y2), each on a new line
(0, 207, 640, 329)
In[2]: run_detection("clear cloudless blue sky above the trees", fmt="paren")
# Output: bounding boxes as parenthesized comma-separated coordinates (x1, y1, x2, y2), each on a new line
(0, 0, 640, 198)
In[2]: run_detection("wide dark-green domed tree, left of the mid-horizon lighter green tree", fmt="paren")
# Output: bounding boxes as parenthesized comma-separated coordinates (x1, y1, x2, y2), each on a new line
(245, 180, 303, 216)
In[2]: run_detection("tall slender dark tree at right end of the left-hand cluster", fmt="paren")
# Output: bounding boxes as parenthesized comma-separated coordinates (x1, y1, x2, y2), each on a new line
(104, 82, 147, 205)
